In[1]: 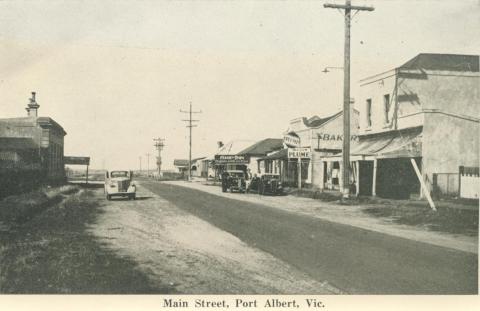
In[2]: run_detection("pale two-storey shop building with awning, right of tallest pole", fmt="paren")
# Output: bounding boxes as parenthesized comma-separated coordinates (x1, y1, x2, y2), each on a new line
(338, 54, 480, 198)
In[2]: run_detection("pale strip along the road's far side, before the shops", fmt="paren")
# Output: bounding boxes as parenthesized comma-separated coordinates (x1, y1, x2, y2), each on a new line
(162, 181, 478, 254)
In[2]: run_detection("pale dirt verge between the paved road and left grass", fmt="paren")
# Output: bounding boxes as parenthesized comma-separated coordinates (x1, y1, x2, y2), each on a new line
(89, 187, 340, 294)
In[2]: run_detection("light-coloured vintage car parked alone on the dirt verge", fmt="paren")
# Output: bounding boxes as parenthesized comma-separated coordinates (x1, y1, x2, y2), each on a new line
(105, 170, 137, 200)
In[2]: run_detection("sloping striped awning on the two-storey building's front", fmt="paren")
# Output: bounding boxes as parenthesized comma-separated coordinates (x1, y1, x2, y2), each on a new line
(326, 126, 422, 159)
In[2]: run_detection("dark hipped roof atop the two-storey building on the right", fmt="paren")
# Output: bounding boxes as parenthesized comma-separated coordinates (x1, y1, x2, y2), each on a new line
(399, 53, 479, 72)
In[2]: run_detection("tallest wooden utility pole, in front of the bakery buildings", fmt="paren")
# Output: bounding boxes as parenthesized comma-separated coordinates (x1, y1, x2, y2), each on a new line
(323, 0, 374, 199)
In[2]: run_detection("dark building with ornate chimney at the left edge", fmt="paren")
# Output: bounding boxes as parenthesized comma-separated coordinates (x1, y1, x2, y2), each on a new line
(0, 92, 66, 182)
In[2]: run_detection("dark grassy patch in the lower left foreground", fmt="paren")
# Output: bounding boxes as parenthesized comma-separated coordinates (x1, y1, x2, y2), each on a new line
(0, 186, 172, 294)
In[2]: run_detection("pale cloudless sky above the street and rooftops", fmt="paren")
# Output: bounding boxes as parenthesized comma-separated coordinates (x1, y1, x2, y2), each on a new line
(0, 0, 480, 169)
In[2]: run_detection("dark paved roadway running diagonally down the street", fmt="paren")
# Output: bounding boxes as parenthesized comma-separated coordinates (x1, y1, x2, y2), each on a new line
(142, 181, 478, 294)
